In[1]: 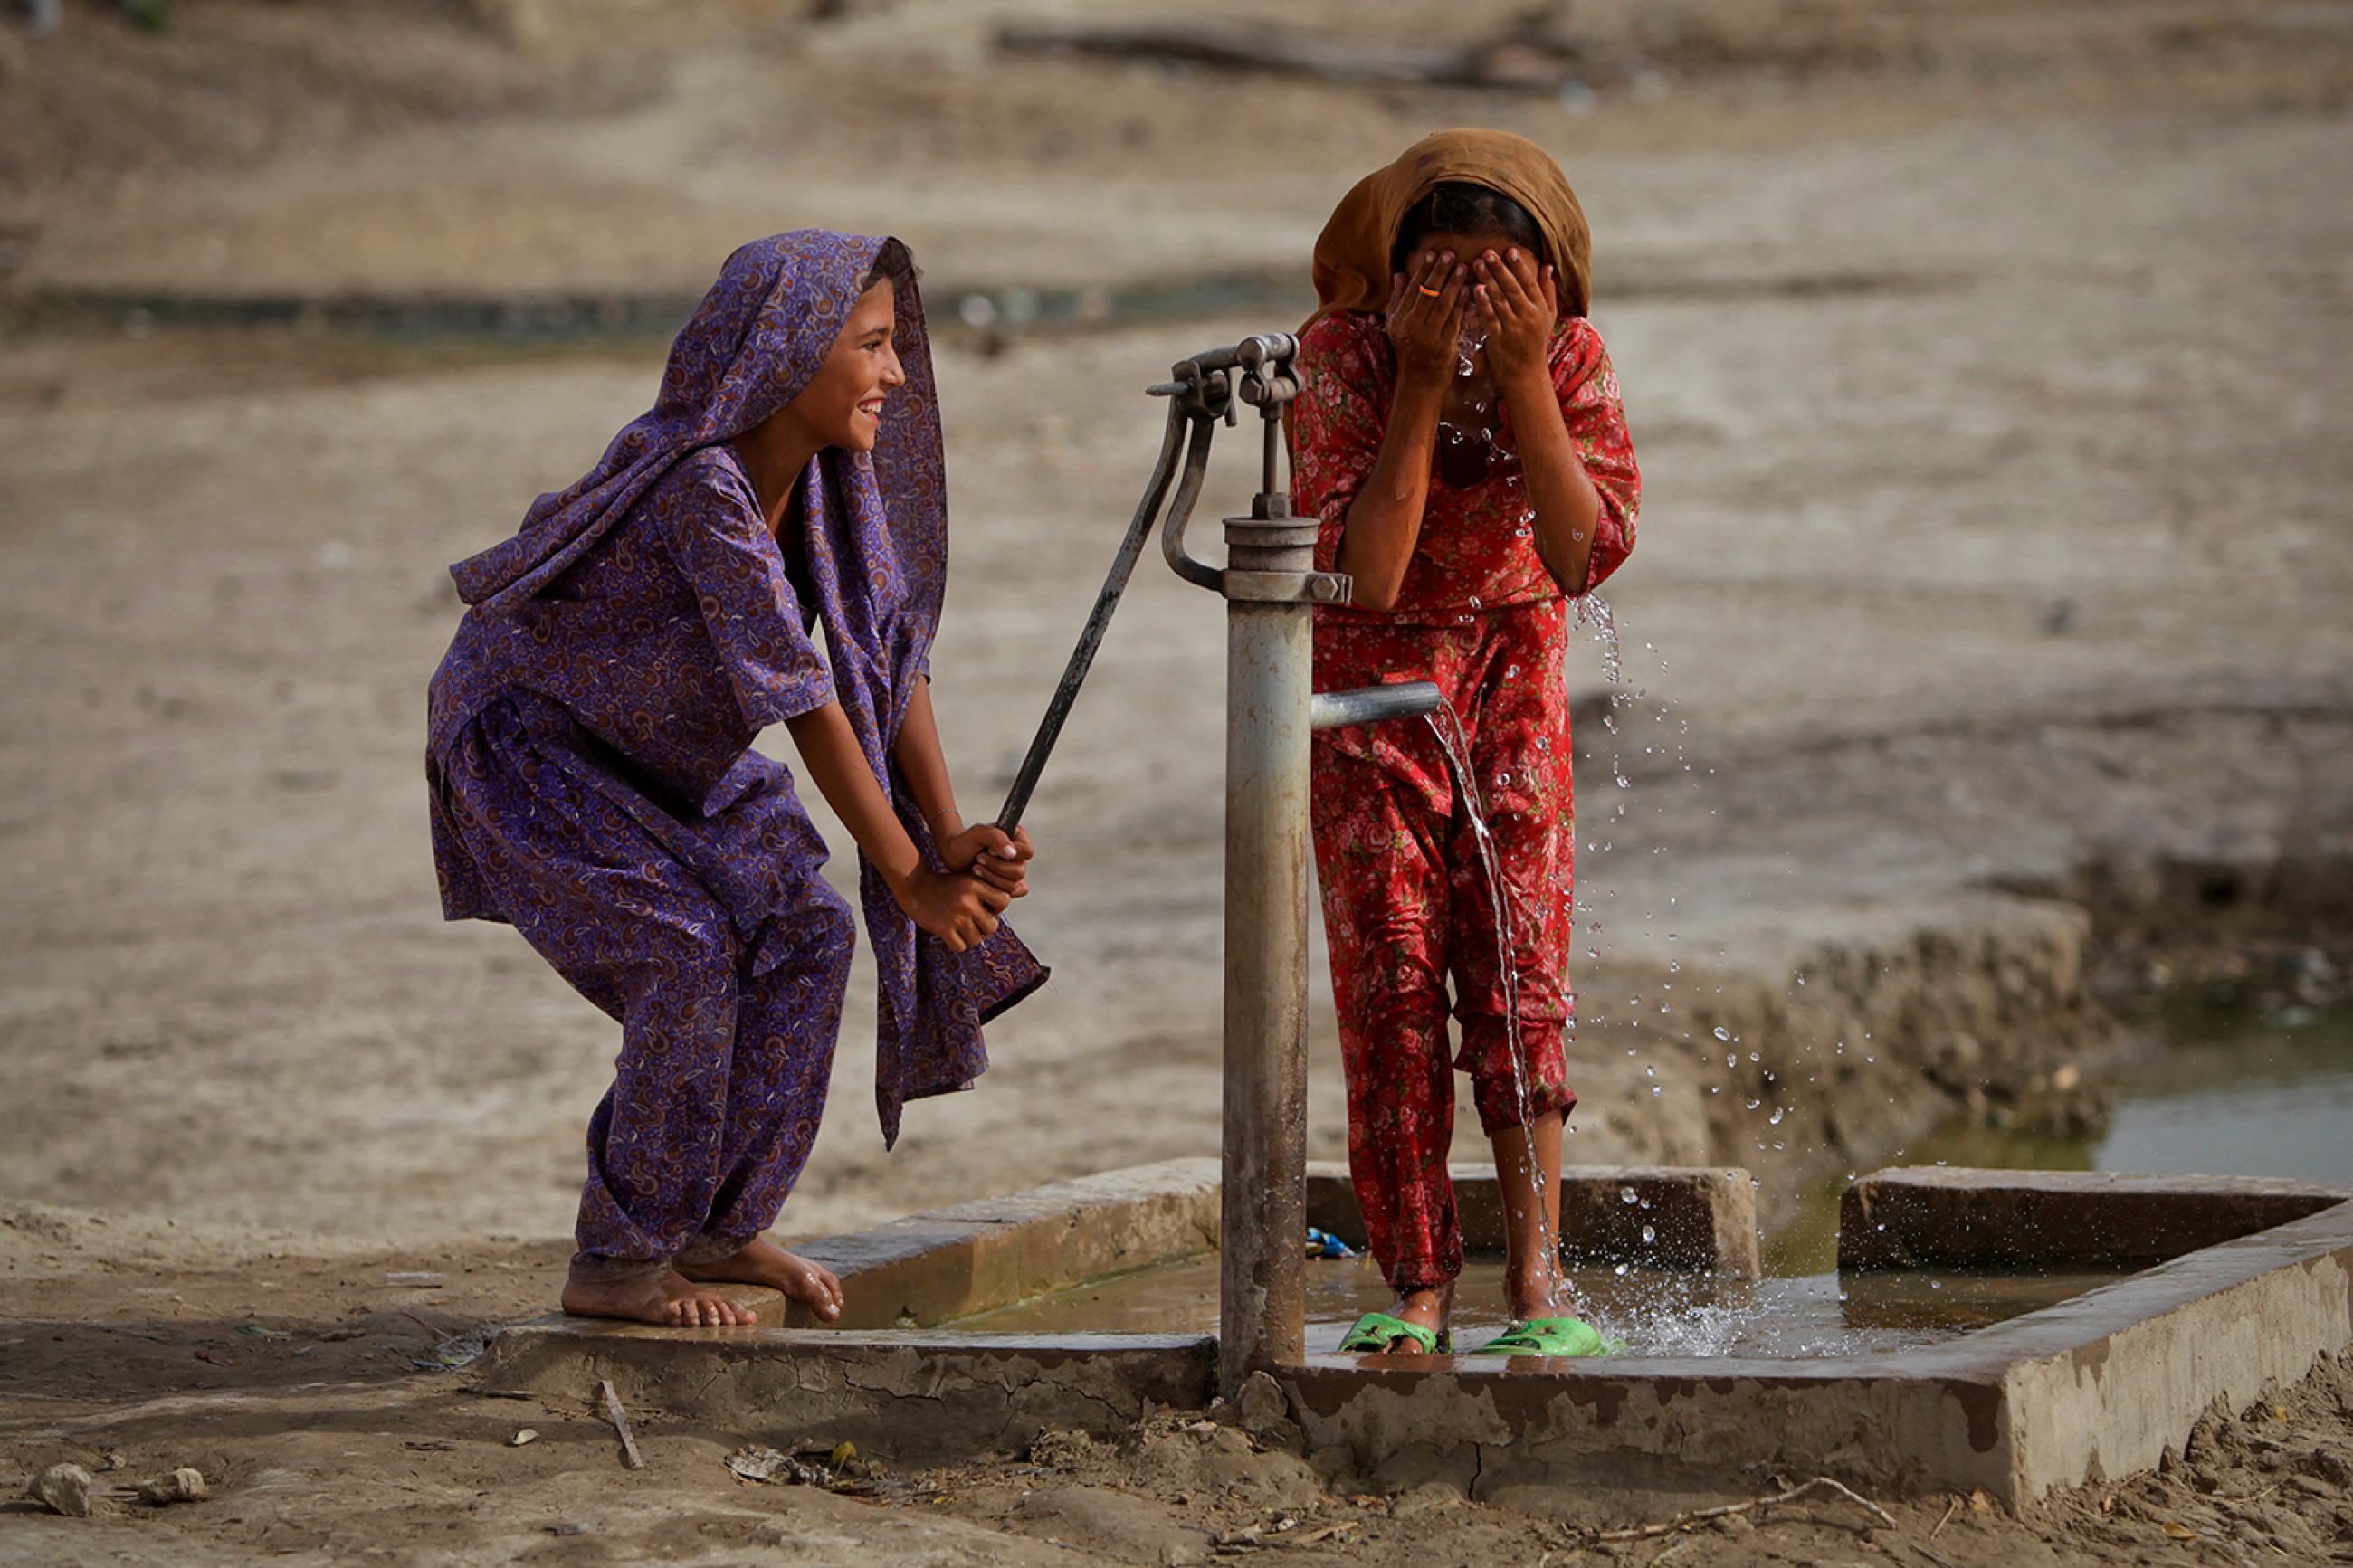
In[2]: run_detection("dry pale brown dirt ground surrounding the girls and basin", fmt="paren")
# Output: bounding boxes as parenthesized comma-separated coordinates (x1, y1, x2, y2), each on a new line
(0, 0, 2353, 1563)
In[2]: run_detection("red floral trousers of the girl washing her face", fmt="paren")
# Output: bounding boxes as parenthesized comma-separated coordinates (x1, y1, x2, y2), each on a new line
(1310, 600, 1577, 1290)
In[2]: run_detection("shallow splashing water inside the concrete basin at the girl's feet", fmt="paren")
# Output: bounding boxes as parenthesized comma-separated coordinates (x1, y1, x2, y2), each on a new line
(950, 1253, 2118, 1356)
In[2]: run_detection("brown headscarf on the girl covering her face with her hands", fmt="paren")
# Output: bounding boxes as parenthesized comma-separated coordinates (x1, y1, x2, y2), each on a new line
(1309, 131, 1593, 319)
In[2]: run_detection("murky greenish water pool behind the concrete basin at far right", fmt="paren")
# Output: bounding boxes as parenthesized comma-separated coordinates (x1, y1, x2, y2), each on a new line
(1765, 992, 2353, 1274)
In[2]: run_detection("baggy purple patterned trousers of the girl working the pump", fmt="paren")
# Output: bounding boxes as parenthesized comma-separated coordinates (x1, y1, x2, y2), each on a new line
(433, 693, 856, 1281)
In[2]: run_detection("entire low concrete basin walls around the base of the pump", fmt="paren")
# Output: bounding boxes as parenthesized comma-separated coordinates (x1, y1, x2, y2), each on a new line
(482, 1162, 2353, 1512)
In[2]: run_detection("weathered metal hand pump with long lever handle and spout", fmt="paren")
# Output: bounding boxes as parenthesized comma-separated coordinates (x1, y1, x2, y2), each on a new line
(997, 334, 1443, 1392)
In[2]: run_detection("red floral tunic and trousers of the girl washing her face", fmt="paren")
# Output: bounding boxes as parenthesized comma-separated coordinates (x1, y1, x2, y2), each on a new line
(1291, 313, 1643, 1290)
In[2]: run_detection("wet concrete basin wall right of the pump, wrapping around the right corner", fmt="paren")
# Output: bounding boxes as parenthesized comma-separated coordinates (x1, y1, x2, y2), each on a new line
(1278, 1168, 2353, 1509)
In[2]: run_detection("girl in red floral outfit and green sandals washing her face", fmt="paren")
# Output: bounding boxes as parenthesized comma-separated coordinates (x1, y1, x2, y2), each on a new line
(1291, 131, 1640, 1354)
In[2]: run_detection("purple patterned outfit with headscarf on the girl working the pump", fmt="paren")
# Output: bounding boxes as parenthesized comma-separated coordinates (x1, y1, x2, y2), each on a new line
(426, 231, 1044, 1278)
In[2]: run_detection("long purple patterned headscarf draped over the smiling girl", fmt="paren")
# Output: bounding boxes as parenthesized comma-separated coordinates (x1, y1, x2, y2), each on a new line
(450, 228, 1047, 1140)
